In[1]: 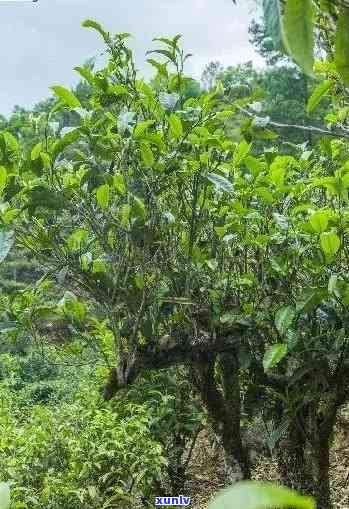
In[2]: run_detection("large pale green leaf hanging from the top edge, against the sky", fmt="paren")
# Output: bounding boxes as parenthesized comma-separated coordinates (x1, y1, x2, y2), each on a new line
(282, 0, 314, 76)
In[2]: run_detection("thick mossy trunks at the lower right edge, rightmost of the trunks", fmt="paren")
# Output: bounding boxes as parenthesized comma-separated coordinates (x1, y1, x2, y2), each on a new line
(277, 351, 349, 509)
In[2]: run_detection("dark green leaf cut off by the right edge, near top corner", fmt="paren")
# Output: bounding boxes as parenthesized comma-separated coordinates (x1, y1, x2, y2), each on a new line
(334, 7, 349, 85)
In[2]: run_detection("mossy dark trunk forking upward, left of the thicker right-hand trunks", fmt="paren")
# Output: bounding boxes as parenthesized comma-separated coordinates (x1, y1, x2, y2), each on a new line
(192, 354, 250, 482)
